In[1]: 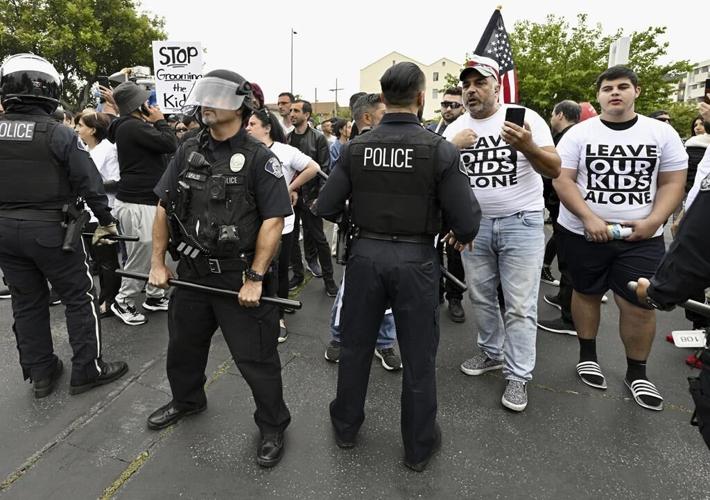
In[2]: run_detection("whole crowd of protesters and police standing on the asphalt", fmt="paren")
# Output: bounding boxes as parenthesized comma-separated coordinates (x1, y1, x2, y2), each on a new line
(0, 51, 710, 470)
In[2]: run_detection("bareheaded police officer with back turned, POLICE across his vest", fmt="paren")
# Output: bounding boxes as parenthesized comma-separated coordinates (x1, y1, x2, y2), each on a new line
(318, 62, 480, 471)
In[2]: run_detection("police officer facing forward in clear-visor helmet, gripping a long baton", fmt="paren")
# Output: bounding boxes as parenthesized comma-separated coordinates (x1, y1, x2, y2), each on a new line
(148, 70, 292, 467)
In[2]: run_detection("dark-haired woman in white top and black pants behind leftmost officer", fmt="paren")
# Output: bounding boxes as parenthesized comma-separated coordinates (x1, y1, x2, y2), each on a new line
(77, 112, 121, 317)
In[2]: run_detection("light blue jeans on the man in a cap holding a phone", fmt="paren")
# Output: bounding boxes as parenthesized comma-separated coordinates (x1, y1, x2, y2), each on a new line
(461, 211, 545, 382)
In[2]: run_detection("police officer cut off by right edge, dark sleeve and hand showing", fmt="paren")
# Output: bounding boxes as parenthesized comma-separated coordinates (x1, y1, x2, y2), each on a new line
(636, 173, 710, 448)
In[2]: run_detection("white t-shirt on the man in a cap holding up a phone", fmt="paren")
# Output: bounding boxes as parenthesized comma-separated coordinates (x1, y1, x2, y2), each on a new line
(444, 104, 554, 219)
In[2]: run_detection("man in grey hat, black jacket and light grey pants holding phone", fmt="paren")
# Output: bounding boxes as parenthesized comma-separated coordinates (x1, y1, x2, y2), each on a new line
(108, 82, 177, 326)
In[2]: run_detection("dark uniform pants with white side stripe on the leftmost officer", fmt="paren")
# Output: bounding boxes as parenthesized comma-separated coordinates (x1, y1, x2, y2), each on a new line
(0, 218, 101, 383)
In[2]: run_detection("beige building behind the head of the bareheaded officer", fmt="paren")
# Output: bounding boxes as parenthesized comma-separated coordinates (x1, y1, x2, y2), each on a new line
(360, 52, 461, 120)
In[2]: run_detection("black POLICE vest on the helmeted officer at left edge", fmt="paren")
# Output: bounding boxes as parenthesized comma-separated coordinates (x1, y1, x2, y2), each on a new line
(0, 113, 72, 210)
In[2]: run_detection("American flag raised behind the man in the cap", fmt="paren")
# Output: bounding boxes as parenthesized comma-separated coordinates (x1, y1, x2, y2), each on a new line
(473, 9, 518, 103)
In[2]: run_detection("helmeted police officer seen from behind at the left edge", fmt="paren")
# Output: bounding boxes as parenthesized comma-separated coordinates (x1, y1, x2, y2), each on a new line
(0, 54, 128, 398)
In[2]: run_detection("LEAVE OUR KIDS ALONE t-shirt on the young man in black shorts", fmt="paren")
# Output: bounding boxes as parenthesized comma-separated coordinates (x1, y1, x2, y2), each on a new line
(557, 115, 688, 236)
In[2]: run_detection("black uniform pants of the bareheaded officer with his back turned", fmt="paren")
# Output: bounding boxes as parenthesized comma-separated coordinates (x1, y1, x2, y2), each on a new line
(330, 239, 440, 463)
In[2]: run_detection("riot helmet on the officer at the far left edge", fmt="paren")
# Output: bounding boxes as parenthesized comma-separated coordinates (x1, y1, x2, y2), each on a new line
(0, 54, 62, 112)
